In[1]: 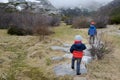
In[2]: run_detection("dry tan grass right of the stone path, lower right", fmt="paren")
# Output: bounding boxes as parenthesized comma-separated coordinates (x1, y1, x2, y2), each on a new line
(88, 25, 120, 80)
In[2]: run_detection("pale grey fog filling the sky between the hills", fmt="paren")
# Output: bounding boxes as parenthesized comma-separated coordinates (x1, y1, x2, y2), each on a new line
(49, 0, 113, 8)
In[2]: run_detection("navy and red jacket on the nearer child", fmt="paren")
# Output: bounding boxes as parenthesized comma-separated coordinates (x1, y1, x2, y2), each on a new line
(70, 41, 86, 58)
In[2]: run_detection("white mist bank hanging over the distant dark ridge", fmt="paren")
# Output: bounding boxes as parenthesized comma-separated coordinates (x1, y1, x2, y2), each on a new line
(49, 0, 111, 11)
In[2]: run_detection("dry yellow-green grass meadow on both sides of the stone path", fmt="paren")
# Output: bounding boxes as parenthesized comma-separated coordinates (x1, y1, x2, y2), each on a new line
(0, 24, 120, 80)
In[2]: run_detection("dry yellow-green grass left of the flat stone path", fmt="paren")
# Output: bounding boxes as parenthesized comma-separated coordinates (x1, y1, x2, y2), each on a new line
(0, 24, 87, 80)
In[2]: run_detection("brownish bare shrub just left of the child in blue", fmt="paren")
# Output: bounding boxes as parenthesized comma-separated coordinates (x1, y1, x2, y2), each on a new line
(72, 16, 90, 28)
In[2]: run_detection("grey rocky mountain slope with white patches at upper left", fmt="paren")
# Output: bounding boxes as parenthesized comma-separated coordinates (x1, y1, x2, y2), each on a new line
(0, 0, 58, 14)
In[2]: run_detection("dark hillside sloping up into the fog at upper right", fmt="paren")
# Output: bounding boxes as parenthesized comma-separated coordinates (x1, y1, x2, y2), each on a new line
(97, 0, 120, 24)
